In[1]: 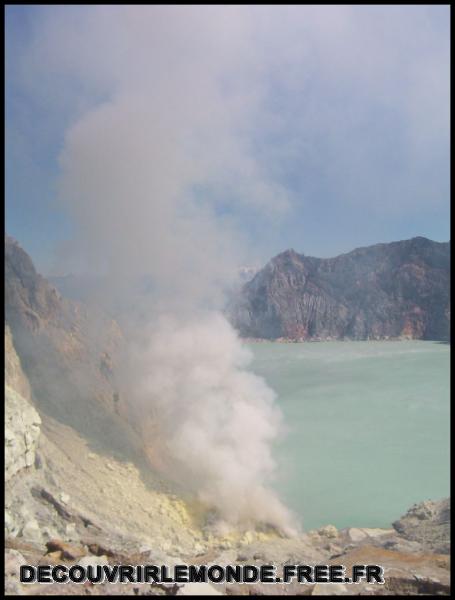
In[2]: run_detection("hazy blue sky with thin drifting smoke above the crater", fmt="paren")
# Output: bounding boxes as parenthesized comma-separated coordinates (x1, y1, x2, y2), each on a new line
(6, 5, 450, 274)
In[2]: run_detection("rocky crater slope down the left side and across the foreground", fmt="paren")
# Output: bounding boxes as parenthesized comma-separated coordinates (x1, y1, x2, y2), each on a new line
(5, 234, 450, 595)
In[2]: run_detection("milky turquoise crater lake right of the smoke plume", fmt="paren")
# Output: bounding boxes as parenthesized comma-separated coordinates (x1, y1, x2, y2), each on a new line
(248, 341, 450, 531)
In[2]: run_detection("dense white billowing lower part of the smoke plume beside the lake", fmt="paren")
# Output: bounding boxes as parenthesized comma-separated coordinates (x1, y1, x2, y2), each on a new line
(128, 313, 291, 533)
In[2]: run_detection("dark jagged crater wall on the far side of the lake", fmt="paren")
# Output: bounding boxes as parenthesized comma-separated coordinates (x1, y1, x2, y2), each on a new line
(228, 237, 450, 340)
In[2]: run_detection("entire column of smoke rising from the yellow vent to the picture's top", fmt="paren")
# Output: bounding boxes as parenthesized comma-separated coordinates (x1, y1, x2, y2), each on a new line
(52, 7, 291, 533)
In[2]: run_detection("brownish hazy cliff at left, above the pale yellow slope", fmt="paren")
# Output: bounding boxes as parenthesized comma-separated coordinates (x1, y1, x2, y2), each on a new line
(5, 237, 146, 456)
